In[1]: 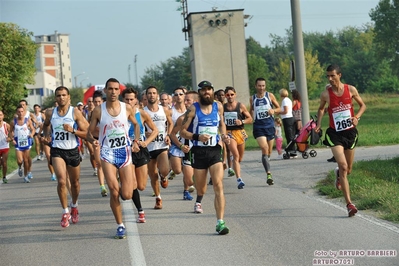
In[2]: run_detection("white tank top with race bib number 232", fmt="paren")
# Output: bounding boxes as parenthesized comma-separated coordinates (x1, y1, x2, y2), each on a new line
(98, 102, 131, 150)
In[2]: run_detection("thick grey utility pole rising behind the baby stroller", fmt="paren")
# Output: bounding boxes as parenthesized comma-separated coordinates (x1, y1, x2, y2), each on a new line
(291, 0, 309, 125)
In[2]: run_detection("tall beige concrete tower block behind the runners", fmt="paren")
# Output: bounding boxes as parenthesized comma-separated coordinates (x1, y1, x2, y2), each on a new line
(187, 9, 249, 105)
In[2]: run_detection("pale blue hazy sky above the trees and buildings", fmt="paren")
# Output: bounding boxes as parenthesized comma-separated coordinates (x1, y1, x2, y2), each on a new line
(0, 0, 379, 85)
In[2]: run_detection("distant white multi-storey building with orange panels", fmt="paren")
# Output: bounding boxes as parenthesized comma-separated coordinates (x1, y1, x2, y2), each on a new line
(26, 31, 72, 107)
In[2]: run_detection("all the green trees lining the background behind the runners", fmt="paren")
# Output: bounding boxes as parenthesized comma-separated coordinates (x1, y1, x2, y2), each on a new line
(0, 0, 399, 117)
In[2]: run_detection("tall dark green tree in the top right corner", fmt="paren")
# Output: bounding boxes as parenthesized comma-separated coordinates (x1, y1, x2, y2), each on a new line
(369, 0, 399, 76)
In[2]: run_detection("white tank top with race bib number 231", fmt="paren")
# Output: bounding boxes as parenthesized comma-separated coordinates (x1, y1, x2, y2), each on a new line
(51, 106, 79, 150)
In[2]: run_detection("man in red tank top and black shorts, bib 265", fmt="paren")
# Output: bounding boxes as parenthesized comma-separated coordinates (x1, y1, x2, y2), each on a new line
(315, 65, 366, 217)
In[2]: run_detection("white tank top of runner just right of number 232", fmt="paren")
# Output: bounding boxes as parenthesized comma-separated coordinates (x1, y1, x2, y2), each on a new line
(144, 106, 168, 151)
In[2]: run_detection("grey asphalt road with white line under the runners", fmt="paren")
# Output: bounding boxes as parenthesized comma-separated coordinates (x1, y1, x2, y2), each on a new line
(0, 145, 399, 266)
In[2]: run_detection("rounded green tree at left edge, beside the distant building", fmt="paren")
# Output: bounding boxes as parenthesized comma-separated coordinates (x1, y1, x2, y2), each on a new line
(0, 23, 37, 119)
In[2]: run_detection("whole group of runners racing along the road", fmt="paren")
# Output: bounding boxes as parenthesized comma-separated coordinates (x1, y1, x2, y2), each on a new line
(0, 66, 365, 239)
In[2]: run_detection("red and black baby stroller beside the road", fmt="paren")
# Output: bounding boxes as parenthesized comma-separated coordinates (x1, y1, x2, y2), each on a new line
(283, 116, 323, 159)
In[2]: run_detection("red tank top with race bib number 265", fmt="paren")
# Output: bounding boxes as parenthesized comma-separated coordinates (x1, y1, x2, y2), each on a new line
(327, 84, 354, 131)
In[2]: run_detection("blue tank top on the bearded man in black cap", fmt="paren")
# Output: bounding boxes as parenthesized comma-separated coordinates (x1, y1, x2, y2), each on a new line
(192, 102, 220, 147)
